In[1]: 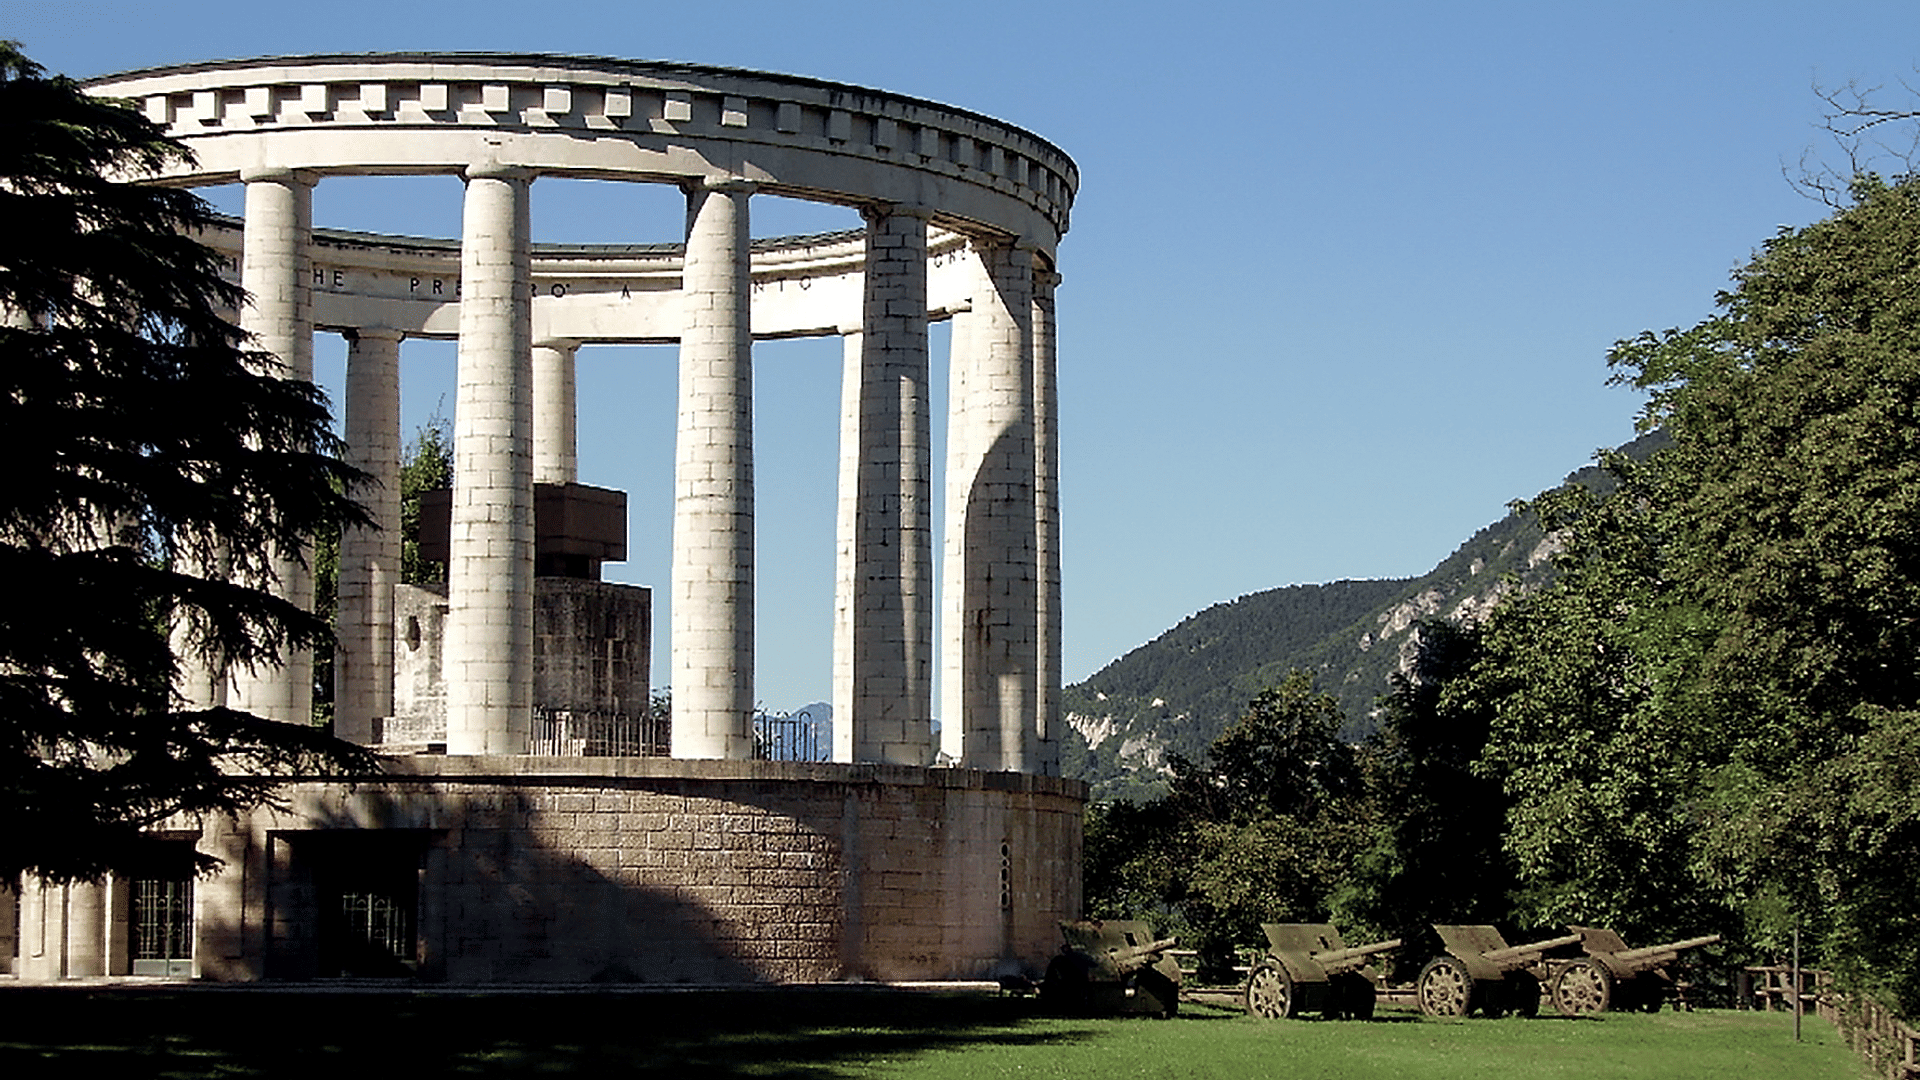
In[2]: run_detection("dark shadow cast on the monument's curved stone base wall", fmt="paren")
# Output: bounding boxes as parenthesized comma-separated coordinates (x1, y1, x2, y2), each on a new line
(249, 772, 787, 984)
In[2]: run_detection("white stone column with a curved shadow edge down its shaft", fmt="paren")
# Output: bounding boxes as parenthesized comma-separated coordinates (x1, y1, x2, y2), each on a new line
(943, 240, 1039, 773)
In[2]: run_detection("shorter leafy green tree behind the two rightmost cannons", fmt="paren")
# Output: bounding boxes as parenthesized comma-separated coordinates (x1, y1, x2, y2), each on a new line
(1440, 466, 1716, 940)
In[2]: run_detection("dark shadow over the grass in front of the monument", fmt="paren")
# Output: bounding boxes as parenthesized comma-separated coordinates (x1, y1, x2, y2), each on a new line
(0, 988, 1094, 1080)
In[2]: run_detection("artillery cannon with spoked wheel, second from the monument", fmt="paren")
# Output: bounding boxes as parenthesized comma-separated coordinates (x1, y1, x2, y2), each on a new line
(1246, 922, 1400, 1020)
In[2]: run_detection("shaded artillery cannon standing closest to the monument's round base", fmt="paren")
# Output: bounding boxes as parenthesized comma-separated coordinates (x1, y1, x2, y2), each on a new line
(1041, 919, 1181, 1017)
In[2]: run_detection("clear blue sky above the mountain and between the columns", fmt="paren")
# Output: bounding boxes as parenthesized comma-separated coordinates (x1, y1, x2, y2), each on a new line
(15, 0, 1920, 709)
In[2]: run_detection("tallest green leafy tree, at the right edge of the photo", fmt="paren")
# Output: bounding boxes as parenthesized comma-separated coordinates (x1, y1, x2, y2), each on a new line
(1613, 177, 1920, 1009)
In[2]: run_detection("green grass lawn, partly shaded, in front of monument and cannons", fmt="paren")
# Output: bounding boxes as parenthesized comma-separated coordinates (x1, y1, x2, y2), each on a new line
(0, 988, 1864, 1080)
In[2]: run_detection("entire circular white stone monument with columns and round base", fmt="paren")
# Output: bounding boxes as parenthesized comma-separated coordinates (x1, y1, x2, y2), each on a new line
(0, 54, 1085, 982)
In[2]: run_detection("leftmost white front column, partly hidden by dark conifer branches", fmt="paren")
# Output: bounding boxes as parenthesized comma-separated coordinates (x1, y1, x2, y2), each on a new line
(228, 169, 313, 724)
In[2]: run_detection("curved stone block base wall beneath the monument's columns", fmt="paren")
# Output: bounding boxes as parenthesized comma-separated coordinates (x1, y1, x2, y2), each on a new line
(194, 757, 1085, 982)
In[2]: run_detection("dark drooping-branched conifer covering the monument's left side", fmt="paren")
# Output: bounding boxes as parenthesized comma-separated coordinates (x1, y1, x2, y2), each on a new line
(0, 42, 367, 880)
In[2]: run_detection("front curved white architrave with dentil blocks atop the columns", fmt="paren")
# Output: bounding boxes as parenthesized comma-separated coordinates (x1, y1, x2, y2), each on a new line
(86, 54, 1079, 252)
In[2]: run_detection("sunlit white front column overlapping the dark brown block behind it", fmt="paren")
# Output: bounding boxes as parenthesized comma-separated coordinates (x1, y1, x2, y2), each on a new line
(444, 165, 534, 753)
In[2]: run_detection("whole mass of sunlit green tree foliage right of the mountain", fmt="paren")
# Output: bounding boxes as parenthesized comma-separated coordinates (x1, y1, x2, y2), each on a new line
(1444, 177, 1920, 1009)
